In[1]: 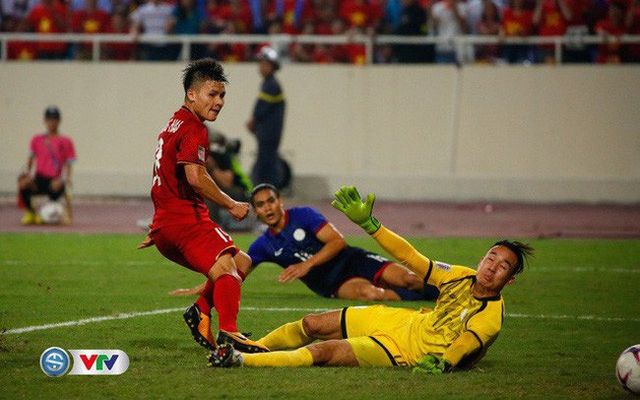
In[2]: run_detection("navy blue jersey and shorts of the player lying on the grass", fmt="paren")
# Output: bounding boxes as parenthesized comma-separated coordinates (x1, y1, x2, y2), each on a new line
(249, 207, 389, 297)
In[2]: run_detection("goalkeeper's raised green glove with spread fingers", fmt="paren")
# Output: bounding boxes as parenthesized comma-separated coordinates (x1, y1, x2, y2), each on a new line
(331, 186, 380, 235)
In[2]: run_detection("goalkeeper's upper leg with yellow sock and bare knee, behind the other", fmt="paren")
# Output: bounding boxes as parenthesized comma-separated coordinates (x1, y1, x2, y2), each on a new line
(258, 310, 342, 350)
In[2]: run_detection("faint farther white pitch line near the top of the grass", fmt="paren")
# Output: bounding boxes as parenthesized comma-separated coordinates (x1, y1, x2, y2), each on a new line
(0, 260, 640, 274)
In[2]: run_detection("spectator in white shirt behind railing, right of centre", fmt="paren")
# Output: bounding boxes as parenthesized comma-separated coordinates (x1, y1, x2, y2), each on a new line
(431, 0, 469, 64)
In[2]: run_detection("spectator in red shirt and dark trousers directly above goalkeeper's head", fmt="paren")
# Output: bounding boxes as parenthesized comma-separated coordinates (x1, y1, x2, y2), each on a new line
(500, 0, 533, 64)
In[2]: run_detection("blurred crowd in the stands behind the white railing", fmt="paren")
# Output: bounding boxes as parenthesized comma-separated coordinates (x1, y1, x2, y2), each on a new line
(0, 0, 640, 64)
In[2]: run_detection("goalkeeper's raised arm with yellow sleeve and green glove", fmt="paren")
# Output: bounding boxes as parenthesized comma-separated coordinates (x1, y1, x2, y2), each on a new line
(331, 186, 432, 279)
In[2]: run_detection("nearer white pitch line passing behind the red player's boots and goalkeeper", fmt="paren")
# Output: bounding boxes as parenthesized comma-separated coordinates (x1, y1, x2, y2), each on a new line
(0, 307, 640, 335)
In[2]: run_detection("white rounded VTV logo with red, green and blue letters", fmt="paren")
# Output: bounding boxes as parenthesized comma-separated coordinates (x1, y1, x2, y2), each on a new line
(69, 350, 129, 375)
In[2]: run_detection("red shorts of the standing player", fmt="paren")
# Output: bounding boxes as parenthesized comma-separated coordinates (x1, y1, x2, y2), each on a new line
(150, 220, 238, 276)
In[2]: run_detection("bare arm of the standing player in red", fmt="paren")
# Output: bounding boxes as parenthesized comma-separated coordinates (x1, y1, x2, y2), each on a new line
(183, 163, 249, 220)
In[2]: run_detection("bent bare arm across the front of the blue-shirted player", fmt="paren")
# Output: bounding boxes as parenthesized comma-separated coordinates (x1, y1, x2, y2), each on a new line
(278, 223, 347, 283)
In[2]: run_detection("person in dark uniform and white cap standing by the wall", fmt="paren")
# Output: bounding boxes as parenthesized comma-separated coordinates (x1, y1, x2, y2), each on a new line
(247, 46, 285, 188)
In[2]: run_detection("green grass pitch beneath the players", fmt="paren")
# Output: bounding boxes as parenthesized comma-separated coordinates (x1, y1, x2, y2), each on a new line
(0, 234, 640, 400)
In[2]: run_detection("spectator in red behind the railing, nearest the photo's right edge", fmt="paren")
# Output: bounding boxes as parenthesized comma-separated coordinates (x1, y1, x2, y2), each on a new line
(596, 1, 625, 64)
